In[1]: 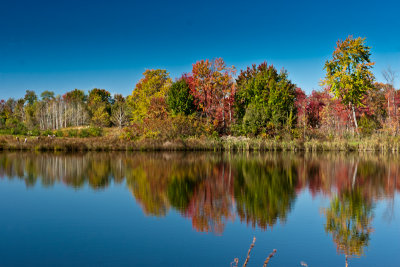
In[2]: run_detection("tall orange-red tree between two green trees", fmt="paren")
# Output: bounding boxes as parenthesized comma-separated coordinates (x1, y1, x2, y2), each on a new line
(186, 58, 236, 132)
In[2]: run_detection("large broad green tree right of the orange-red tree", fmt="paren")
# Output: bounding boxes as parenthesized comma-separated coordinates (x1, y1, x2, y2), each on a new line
(235, 62, 296, 134)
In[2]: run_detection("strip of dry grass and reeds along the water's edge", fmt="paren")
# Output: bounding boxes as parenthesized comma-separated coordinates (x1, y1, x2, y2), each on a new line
(0, 135, 400, 152)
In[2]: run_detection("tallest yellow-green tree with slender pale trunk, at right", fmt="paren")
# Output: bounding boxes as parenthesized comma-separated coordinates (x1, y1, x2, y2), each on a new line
(321, 36, 374, 134)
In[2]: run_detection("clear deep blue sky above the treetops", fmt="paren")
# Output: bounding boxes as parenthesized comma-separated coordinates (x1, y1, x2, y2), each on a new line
(0, 0, 400, 99)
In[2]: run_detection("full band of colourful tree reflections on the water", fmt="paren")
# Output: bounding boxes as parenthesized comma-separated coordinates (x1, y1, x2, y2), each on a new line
(0, 153, 400, 261)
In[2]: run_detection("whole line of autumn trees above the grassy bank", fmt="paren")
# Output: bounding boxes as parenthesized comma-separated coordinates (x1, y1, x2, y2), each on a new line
(0, 36, 400, 139)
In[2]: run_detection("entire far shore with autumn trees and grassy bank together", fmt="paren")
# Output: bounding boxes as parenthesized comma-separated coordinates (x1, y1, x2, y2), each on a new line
(0, 36, 400, 151)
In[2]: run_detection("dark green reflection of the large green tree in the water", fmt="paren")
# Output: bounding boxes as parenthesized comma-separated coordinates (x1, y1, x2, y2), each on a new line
(234, 159, 297, 229)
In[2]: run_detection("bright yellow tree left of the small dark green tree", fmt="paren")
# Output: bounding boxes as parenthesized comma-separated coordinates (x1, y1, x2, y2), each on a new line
(127, 69, 172, 122)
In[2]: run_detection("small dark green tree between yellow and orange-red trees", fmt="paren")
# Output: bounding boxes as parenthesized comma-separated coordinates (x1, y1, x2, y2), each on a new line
(167, 78, 195, 115)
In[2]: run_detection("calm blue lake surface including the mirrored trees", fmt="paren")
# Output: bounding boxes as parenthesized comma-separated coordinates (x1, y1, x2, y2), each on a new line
(0, 153, 400, 267)
